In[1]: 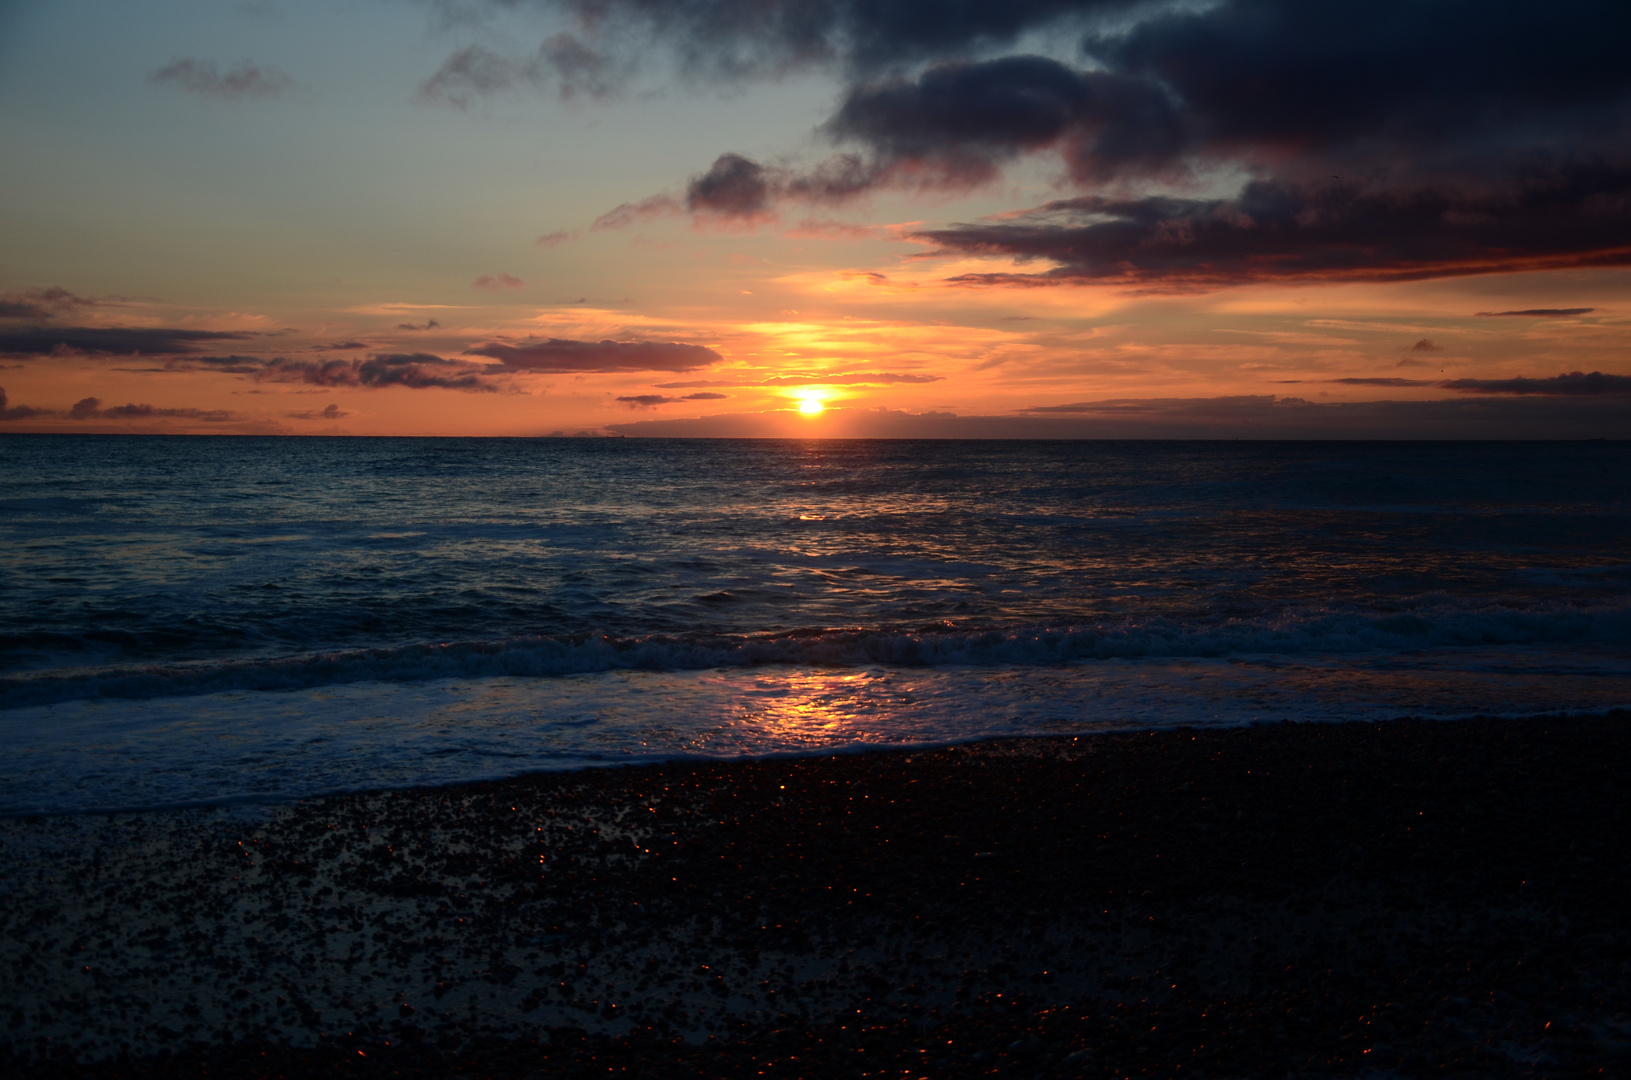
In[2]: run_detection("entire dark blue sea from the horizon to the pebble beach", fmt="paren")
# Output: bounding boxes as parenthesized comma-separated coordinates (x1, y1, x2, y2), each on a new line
(0, 436, 1631, 814)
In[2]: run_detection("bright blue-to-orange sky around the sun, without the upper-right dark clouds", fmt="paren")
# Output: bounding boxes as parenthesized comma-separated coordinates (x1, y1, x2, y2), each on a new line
(0, 0, 1631, 436)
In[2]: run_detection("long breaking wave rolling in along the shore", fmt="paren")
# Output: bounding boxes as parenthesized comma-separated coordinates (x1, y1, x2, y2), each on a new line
(0, 599, 1631, 710)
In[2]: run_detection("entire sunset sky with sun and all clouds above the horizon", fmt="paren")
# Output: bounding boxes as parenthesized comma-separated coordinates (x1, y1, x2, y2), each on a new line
(0, 0, 1631, 439)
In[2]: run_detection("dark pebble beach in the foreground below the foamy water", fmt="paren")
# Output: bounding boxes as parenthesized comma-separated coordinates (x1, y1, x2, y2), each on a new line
(0, 713, 1631, 1078)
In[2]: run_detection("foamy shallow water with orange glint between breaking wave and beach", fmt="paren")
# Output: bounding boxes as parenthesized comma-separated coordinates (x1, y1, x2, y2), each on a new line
(0, 646, 1631, 814)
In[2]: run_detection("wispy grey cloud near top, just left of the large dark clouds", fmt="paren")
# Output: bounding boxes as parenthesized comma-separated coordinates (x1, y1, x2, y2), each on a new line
(419, 34, 626, 109)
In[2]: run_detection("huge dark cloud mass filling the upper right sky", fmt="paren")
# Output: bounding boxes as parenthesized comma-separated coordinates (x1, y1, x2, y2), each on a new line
(561, 0, 1631, 289)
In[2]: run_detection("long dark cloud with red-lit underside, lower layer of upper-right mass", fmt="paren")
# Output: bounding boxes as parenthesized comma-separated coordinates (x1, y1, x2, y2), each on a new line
(915, 163, 1631, 289)
